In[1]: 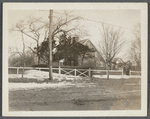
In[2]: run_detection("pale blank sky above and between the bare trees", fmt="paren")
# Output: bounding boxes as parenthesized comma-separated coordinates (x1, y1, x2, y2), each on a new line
(8, 10, 141, 60)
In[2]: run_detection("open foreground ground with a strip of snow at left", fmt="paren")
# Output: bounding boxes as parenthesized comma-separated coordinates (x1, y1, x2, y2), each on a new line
(9, 78, 141, 111)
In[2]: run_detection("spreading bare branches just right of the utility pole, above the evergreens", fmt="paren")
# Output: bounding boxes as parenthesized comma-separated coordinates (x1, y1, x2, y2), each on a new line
(49, 11, 88, 39)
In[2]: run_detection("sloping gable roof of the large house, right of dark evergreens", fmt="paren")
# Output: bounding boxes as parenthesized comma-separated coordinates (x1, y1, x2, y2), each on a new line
(79, 39, 104, 61)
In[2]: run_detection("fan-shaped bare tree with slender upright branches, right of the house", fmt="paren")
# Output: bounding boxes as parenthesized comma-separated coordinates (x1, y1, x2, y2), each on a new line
(99, 24, 125, 79)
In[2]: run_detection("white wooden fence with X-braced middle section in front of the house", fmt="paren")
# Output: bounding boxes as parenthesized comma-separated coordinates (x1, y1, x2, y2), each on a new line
(8, 67, 123, 77)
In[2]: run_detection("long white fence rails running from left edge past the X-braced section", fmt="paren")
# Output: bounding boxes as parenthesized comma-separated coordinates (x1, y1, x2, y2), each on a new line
(8, 67, 127, 77)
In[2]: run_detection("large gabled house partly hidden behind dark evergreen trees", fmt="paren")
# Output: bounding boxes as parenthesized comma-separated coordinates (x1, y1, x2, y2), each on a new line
(49, 38, 105, 69)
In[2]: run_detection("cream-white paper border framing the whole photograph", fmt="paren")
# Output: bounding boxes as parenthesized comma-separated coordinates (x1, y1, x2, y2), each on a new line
(2, 3, 148, 117)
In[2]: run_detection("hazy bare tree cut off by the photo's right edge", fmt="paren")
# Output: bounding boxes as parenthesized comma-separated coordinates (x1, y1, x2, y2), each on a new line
(130, 23, 141, 70)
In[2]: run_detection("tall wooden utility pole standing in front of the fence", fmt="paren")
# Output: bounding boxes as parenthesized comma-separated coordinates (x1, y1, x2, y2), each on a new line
(49, 10, 53, 80)
